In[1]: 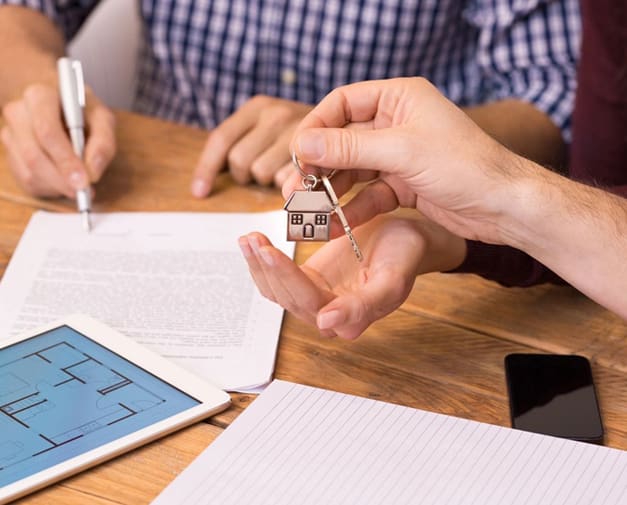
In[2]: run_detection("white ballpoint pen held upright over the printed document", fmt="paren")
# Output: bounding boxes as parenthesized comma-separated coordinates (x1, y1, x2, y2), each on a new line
(57, 58, 91, 231)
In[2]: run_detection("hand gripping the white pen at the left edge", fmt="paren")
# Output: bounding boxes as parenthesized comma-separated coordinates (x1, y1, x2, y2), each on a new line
(0, 84, 115, 198)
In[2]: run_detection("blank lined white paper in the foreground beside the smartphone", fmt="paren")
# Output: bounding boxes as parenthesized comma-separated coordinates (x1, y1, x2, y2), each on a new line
(153, 381, 627, 505)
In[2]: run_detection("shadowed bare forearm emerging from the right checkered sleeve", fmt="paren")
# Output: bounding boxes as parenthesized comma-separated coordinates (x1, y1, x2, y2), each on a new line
(464, 99, 566, 171)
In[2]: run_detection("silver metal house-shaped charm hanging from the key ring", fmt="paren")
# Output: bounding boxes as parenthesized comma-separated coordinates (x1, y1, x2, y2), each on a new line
(283, 188, 335, 241)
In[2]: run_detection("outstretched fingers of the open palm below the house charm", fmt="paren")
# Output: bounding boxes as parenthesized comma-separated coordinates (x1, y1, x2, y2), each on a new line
(239, 233, 335, 324)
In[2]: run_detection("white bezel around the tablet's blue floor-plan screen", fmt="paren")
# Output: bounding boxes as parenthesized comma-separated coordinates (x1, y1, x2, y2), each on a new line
(0, 315, 231, 503)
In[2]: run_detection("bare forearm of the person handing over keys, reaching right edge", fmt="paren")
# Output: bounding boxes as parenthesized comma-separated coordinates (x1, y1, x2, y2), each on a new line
(499, 163, 627, 317)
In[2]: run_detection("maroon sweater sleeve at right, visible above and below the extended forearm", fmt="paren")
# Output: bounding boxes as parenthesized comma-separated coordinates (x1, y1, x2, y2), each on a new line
(454, 0, 627, 286)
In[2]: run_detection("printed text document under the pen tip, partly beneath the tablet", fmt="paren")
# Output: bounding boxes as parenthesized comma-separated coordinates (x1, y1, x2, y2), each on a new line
(0, 211, 294, 391)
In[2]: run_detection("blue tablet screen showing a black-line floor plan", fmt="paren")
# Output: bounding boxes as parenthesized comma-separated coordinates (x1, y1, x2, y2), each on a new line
(0, 326, 200, 487)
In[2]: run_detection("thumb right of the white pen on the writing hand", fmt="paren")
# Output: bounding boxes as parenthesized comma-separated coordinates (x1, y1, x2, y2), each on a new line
(84, 94, 116, 183)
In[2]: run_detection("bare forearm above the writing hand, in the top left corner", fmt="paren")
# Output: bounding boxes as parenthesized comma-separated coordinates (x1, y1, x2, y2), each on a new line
(0, 6, 65, 105)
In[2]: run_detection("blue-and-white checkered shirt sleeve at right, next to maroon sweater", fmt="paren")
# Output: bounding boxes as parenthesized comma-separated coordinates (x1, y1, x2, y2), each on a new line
(466, 0, 581, 141)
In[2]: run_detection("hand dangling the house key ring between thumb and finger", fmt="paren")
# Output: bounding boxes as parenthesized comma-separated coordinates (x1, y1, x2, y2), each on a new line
(283, 78, 525, 243)
